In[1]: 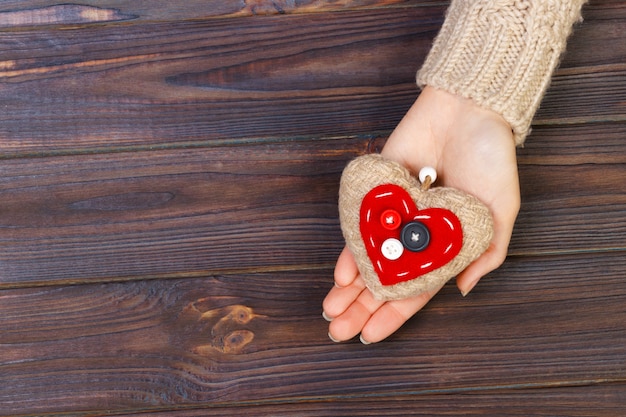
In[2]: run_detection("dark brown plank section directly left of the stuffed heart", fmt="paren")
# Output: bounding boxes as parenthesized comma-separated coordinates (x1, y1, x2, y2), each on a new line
(0, 140, 352, 285)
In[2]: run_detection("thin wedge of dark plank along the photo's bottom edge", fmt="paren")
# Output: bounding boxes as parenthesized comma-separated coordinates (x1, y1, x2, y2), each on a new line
(109, 384, 626, 417)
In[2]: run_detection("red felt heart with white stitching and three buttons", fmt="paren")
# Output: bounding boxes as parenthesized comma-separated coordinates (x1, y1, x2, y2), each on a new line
(360, 184, 463, 286)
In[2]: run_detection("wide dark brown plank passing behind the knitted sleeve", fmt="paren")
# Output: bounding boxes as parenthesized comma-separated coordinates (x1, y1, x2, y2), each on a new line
(0, 2, 626, 157)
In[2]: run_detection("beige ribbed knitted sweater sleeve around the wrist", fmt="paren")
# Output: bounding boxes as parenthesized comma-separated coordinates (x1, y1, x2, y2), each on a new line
(417, 0, 586, 145)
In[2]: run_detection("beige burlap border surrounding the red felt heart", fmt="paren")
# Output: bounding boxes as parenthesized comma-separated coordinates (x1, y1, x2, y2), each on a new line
(339, 155, 493, 300)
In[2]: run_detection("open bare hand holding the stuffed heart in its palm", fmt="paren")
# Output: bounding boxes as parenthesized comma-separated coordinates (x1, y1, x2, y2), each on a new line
(323, 87, 520, 343)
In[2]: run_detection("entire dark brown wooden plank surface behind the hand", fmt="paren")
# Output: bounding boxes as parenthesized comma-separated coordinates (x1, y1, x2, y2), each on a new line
(0, 0, 626, 417)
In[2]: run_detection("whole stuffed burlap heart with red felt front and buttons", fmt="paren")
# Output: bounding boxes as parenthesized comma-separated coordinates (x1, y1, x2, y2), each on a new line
(339, 155, 493, 300)
